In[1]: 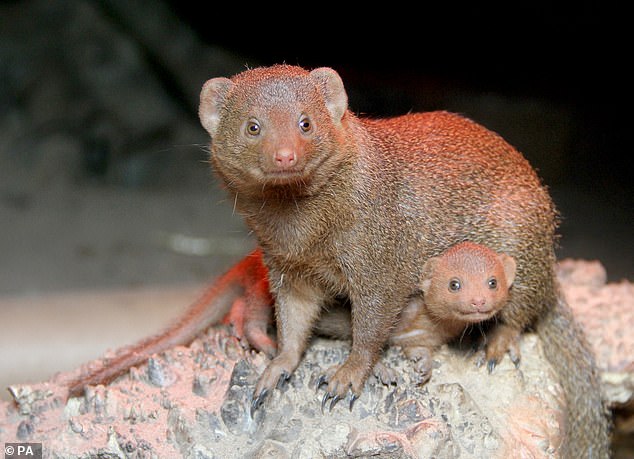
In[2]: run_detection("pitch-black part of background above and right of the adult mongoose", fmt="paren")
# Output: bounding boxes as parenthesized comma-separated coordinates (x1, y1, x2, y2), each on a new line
(173, 2, 634, 279)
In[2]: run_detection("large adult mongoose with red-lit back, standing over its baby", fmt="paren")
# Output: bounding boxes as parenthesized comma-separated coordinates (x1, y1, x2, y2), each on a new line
(199, 65, 608, 456)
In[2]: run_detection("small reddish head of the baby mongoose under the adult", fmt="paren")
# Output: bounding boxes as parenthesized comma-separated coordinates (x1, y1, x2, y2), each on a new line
(421, 242, 516, 323)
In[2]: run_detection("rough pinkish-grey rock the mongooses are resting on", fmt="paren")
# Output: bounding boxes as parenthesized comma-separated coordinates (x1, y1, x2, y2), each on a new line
(0, 262, 634, 458)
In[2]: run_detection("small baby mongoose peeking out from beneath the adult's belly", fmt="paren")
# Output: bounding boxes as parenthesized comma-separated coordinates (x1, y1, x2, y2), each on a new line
(316, 241, 516, 383)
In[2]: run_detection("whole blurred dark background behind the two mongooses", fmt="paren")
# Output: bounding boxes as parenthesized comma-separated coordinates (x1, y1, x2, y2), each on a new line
(0, 0, 634, 410)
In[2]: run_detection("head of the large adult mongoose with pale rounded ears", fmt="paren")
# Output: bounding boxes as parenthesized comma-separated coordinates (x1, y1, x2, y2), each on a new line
(199, 65, 348, 194)
